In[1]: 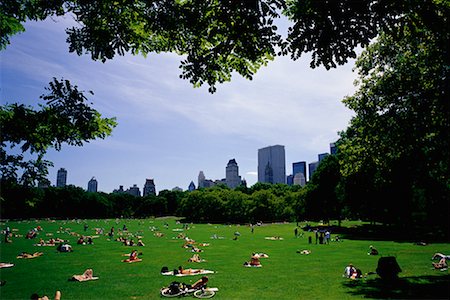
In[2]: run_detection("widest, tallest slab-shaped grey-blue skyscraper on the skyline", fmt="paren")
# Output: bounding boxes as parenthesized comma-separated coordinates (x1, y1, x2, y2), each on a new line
(258, 145, 286, 183)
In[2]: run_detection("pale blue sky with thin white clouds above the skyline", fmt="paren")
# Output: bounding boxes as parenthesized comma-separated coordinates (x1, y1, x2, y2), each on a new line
(0, 17, 356, 192)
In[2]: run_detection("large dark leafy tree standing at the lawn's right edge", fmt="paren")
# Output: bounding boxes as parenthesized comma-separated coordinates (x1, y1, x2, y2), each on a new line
(339, 18, 450, 224)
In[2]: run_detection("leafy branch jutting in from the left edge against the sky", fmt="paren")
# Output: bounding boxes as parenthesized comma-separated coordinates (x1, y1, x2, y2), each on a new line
(0, 78, 116, 186)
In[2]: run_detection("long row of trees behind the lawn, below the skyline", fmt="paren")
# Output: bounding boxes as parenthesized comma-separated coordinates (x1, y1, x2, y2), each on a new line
(0, 149, 448, 228)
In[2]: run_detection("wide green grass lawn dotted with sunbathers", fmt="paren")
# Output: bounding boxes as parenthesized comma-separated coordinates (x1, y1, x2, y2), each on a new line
(0, 218, 450, 299)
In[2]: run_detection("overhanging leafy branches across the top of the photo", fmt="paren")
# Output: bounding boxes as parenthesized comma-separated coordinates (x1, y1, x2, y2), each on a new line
(4, 0, 448, 92)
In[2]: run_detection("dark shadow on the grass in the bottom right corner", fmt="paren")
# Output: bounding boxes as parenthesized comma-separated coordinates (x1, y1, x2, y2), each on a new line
(344, 274, 450, 299)
